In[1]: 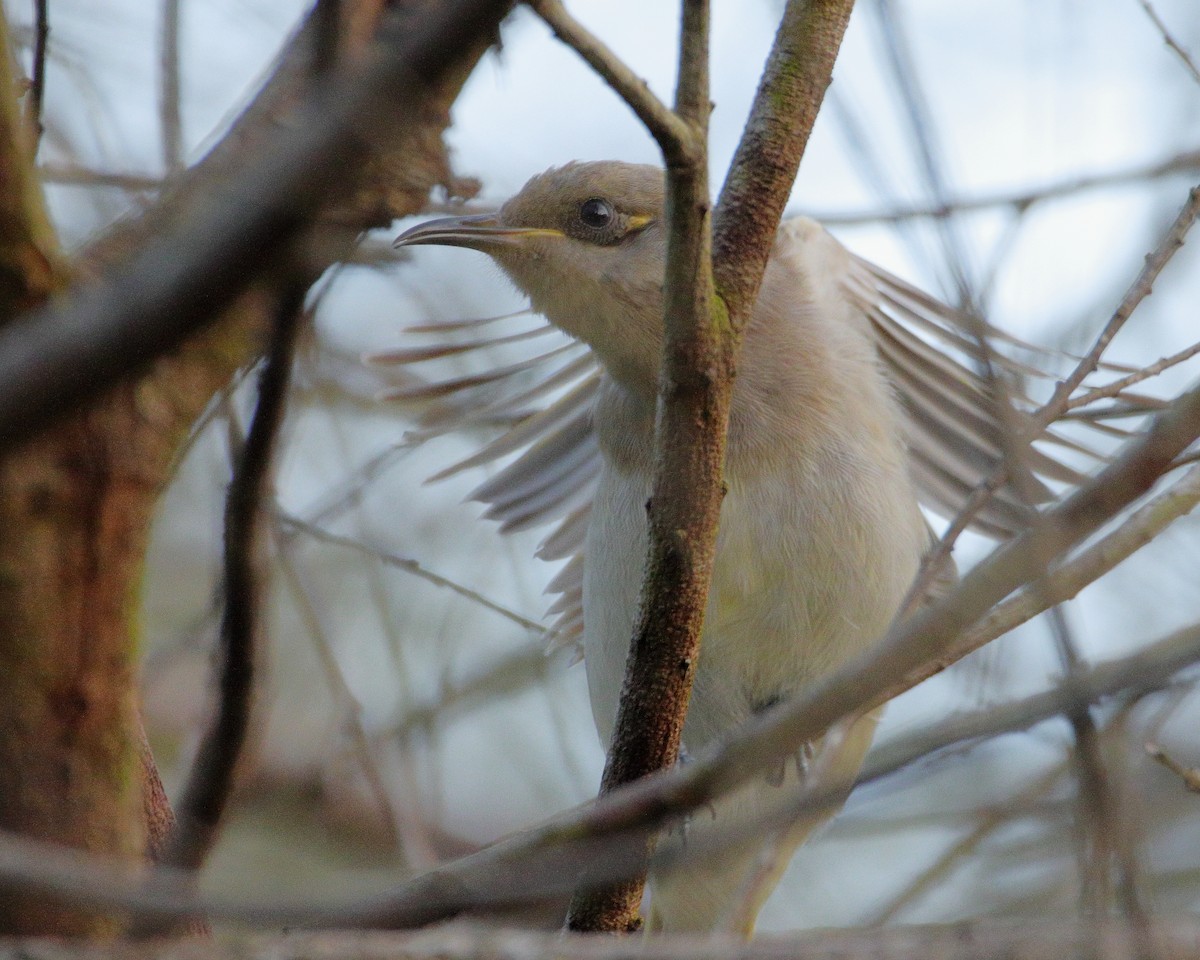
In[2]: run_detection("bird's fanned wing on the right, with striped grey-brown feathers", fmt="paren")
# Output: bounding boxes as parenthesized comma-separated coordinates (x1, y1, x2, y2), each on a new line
(844, 257, 1156, 539)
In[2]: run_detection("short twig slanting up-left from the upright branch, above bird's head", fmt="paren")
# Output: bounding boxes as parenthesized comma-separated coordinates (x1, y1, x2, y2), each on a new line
(529, 0, 698, 164)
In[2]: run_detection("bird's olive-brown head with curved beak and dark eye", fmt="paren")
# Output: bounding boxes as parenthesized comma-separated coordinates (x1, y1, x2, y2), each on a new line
(395, 162, 666, 391)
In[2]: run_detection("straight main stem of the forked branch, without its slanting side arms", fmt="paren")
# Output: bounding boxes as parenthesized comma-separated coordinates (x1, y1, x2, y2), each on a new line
(568, 0, 710, 931)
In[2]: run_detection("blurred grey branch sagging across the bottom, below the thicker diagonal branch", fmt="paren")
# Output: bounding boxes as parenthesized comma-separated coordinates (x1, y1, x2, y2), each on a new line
(0, 625, 1200, 931)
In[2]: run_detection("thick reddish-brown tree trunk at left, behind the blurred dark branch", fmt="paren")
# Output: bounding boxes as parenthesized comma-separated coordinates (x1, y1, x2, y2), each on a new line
(0, 0, 501, 935)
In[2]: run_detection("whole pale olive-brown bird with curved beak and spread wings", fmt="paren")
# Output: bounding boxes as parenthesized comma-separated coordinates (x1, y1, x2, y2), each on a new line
(381, 161, 1113, 936)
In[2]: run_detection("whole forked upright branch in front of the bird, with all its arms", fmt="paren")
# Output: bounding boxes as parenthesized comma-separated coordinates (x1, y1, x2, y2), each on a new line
(552, 0, 853, 931)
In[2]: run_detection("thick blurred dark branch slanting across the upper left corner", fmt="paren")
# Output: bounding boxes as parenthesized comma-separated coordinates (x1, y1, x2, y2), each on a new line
(0, 0, 511, 446)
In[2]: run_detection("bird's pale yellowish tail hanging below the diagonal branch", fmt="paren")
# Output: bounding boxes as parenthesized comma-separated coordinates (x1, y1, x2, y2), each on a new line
(646, 710, 881, 937)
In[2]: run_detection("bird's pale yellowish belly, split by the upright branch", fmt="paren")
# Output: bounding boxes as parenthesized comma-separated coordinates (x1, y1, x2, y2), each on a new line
(583, 431, 928, 750)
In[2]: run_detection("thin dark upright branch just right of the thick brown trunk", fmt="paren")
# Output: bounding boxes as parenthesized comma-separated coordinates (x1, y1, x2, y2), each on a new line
(162, 280, 305, 870)
